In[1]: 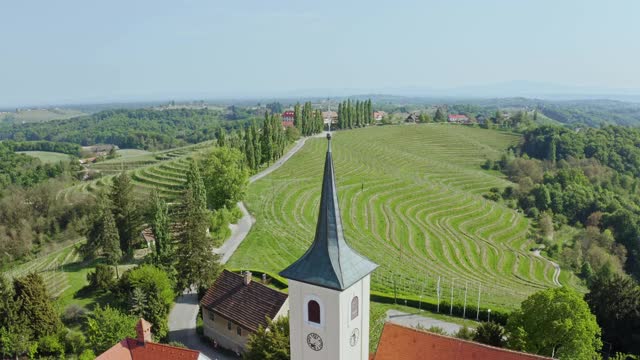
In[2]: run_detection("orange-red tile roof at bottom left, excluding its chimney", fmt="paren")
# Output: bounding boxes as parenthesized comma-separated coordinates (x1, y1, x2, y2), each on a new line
(96, 338, 200, 360)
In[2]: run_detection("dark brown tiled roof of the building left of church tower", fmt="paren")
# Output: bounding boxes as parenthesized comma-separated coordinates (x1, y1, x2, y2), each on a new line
(200, 270, 288, 331)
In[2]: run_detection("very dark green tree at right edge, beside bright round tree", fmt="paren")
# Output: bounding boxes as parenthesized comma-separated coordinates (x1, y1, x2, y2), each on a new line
(586, 272, 640, 354)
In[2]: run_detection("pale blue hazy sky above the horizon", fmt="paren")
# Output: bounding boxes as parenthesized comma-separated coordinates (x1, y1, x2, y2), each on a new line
(0, 0, 640, 106)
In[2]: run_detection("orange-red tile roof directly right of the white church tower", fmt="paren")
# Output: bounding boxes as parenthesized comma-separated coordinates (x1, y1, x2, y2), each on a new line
(373, 323, 550, 360)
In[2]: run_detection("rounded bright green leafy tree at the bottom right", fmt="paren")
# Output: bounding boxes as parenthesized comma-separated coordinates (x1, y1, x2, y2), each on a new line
(507, 287, 602, 360)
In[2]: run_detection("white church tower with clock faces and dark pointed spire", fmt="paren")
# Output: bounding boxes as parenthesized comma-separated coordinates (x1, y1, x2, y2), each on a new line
(280, 133, 378, 360)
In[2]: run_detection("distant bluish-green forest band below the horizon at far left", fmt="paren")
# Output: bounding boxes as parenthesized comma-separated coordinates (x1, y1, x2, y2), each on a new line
(0, 106, 252, 150)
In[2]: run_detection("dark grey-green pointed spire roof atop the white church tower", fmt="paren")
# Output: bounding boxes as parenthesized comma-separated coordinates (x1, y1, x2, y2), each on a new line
(280, 133, 378, 290)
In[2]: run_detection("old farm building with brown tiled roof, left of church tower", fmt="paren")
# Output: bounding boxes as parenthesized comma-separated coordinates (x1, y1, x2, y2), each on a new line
(200, 270, 289, 353)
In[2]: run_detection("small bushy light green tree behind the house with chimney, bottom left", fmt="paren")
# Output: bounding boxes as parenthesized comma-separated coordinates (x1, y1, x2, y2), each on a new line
(87, 305, 136, 354)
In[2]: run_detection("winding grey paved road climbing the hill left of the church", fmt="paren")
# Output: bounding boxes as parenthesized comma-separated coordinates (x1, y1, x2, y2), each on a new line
(169, 132, 326, 360)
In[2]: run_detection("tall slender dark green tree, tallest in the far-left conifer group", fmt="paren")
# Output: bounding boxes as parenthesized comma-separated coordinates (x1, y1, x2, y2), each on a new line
(109, 171, 139, 256)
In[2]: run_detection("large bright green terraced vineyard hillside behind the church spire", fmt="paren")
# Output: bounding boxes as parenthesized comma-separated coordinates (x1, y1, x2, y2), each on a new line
(228, 124, 569, 309)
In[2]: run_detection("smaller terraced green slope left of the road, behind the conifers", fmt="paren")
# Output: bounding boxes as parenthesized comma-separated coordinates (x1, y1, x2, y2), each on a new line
(58, 142, 211, 200)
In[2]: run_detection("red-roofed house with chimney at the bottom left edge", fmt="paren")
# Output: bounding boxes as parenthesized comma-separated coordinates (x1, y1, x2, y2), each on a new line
(96, 318, 210, 360)
